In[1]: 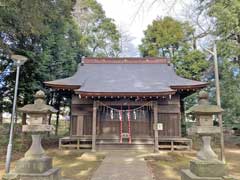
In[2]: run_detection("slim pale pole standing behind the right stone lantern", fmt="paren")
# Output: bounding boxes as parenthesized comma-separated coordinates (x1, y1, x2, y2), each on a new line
(213, 42, 225, 163)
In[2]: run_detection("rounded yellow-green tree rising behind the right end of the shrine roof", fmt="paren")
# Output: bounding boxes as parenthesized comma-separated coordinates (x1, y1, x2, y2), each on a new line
(139, 17, 208, 80)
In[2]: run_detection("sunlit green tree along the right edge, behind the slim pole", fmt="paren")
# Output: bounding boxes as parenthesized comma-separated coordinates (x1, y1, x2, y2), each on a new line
(199, 0, 240, 128)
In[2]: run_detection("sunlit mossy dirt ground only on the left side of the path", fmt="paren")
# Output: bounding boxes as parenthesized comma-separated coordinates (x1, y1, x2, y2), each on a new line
(0, 149, 105, 180)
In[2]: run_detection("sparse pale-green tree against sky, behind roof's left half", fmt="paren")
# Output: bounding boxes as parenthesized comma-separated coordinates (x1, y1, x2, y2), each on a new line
(73, 0, 120, 57)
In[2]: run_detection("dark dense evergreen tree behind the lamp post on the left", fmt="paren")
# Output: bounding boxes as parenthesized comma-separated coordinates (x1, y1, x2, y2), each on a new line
(0, 0, 84, 121)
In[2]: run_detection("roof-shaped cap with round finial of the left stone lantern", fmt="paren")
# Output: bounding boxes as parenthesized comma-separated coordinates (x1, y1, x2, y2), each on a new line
(18, 90, 57, 114)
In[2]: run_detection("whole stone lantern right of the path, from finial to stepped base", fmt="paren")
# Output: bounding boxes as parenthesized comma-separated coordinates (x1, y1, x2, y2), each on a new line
(181, 91, 233, 180)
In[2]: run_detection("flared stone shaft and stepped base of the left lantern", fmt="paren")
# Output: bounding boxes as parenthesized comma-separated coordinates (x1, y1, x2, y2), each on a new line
(9, 135, 61, 180)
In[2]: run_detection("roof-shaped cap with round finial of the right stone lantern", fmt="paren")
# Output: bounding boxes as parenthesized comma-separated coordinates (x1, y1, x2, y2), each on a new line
(188, 91, 224, 115)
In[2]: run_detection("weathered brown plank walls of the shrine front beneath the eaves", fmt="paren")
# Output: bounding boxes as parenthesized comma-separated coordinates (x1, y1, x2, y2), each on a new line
(70, 95, 181, 138)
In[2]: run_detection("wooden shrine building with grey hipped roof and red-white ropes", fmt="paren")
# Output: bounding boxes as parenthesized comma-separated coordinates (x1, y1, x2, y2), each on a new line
(45, 58, 207, 151)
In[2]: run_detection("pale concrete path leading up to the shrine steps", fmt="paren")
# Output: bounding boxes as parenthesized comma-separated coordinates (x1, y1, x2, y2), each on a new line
(91, 150, 153, 180)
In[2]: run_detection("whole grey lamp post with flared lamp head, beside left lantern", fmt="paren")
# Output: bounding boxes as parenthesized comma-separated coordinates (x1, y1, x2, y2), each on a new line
(5, 55, 27, 174)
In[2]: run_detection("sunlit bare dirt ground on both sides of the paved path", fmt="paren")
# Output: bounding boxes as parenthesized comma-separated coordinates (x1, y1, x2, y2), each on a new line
(0, 137, 240, 180)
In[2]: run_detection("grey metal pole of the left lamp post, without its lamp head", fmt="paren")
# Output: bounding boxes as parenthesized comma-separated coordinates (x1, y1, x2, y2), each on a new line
(5, 63, 21, 174)
